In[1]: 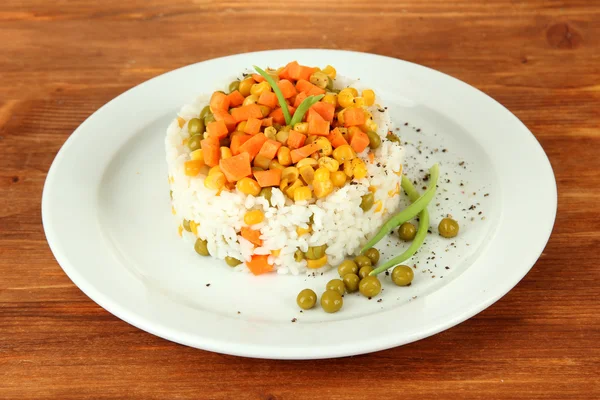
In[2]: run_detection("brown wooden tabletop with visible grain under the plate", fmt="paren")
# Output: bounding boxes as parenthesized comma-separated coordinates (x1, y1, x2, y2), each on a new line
(0, 0, 600, 399)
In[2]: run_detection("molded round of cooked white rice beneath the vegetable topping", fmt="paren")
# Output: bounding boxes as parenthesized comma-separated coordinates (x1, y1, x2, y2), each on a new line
(165, 73, 404, 275)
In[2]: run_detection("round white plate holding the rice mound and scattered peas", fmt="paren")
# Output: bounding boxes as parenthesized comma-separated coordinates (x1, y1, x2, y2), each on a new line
(42, 50, 556, 359)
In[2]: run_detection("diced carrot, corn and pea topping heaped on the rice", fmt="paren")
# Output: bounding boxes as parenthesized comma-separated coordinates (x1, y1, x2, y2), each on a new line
(179, 61, 381, 203)
